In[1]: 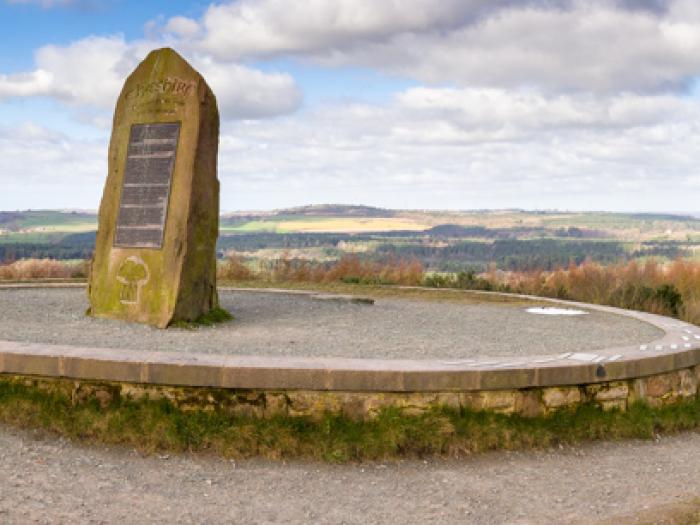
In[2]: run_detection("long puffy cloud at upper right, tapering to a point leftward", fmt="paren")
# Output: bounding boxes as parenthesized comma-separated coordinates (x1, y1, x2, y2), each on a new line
(374, 5, 700, 92)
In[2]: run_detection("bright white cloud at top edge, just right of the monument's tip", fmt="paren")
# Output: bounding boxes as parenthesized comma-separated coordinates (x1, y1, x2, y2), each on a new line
(196, 0, 470, 60)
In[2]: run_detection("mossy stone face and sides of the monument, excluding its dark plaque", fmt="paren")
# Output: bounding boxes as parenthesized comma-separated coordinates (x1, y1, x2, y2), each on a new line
(88, 48, 219, 328)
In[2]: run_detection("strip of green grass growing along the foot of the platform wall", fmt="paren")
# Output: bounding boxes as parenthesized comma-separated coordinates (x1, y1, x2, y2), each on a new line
(0, 379, 700, 462)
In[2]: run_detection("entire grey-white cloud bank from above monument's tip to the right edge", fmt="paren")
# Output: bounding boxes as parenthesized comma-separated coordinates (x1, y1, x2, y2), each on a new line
(192, 0, 700, 92)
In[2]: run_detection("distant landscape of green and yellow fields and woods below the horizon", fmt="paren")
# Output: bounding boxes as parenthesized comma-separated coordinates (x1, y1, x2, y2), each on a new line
(0, 205, 700, 272)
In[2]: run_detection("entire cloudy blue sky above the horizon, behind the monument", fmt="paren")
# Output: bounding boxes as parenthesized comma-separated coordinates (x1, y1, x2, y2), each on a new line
(0, 0, 700, 212)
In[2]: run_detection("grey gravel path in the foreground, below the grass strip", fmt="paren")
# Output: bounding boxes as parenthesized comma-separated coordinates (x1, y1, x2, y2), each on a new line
(0, 425, 700, 524)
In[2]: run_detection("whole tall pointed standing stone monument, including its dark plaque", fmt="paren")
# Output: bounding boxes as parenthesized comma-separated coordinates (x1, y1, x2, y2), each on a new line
(88, 48, 219, 328)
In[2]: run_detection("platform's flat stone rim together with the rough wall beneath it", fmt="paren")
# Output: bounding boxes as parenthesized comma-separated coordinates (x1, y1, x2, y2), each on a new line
(0, 285, 700, 417)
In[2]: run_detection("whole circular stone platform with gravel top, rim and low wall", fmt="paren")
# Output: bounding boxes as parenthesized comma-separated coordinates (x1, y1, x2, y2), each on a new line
(0, 283, 700, 417)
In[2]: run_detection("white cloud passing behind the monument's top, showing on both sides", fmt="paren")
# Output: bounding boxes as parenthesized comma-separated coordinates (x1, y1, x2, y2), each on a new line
(0, 36, 302, 119)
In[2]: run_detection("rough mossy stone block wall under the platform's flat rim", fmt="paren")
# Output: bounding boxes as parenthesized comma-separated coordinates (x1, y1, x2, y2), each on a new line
(0, 366, 700, 420)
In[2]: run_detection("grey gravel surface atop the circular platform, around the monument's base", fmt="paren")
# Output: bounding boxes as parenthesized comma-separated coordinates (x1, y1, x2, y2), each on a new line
(0, 289, 663, 359)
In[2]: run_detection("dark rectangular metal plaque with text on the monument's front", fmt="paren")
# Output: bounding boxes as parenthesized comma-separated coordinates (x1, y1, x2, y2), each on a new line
(114, 122, 180, 249)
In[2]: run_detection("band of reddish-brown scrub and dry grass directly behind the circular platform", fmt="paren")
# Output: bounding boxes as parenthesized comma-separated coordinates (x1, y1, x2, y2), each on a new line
(8, 252, 700, 325)
